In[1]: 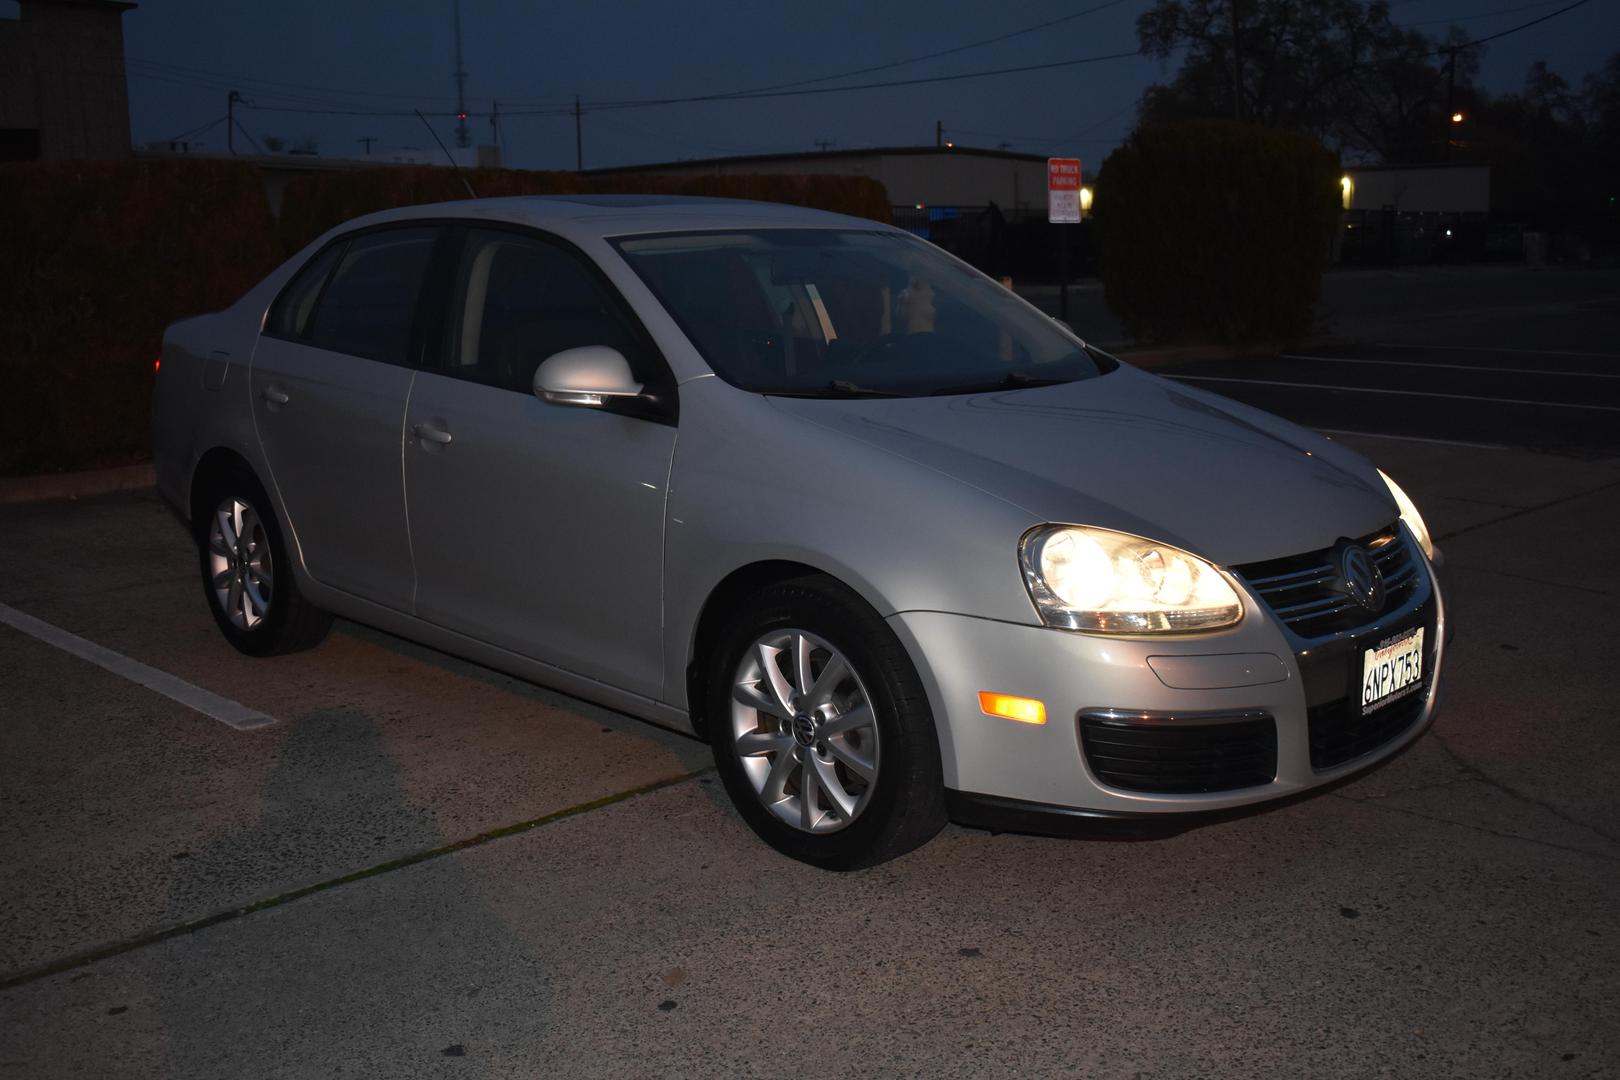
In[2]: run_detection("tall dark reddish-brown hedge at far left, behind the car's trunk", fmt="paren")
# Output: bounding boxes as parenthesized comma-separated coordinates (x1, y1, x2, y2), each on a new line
(0, 160, 280, 473)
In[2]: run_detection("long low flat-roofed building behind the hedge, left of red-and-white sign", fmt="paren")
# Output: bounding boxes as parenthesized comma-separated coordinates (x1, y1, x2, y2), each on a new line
(586, 146, 1047, 215)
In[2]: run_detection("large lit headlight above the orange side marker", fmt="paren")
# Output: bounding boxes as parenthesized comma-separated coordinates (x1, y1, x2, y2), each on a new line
(1019, 525, 1243, 633)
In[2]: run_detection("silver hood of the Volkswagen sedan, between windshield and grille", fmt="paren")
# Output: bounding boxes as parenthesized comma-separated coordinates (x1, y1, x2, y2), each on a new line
(770, 366, 1398, 567)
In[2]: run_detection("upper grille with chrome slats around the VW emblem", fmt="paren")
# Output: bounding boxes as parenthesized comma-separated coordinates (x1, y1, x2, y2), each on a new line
(1234, 525, 1418, 638)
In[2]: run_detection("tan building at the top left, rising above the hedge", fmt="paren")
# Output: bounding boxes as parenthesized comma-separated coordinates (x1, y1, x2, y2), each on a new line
(0, 0, 134, 162)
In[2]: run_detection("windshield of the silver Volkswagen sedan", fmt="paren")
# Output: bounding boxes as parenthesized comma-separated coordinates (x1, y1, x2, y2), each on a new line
(616, 228, 1113, 397)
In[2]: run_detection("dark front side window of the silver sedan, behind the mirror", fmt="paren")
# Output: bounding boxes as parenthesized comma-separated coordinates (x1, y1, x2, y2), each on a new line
(444, 228, 656, 393)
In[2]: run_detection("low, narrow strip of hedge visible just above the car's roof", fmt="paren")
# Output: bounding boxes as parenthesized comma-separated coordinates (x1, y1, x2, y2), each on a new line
(282, 167, 889, 253)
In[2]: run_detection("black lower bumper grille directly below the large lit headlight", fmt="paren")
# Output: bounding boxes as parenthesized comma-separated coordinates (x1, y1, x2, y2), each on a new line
(1081, 714, 1277, 793)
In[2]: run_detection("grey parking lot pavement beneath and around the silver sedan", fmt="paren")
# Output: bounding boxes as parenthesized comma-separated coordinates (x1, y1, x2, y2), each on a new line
(0, 427, 1620, 1078)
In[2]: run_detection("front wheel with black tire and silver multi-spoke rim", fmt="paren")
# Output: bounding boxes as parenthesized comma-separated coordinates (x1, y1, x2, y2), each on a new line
(705, 578, 946, 870)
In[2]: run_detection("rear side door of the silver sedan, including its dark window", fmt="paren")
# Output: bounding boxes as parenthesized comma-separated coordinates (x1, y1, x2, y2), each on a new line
(249, 225, 442, 612)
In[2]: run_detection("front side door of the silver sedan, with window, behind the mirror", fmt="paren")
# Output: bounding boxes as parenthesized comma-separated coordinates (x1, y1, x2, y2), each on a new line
(405, 228, 676, 696)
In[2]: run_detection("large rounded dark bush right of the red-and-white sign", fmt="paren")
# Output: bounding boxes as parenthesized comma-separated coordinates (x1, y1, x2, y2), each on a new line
(1095, 120, 1340, 343)
